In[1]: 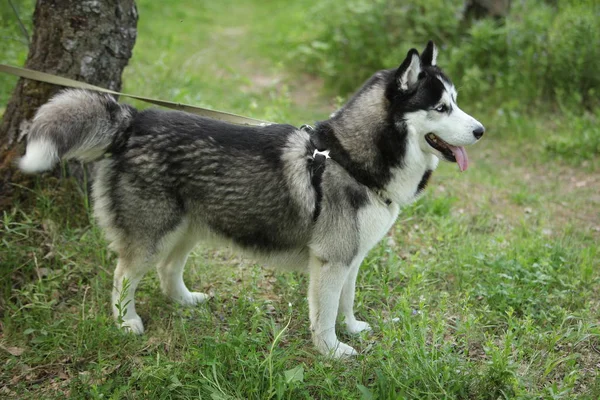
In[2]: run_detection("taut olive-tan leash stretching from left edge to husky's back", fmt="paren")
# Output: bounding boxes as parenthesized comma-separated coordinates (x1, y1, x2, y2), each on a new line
(0, 64, 273, 126)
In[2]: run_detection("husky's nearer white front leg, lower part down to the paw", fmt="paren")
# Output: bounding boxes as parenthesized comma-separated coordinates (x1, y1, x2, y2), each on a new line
(308, 255, 357, 358)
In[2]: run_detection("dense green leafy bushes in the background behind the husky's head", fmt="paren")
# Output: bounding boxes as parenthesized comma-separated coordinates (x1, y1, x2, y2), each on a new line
(297, 0, 600, 109)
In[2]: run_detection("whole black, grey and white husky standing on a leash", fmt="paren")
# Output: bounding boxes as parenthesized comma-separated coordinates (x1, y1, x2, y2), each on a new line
(20, 42, 484, 357)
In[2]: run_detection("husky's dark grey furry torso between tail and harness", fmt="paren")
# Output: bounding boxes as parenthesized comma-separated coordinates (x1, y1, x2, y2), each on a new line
(95, 110, 314, 251)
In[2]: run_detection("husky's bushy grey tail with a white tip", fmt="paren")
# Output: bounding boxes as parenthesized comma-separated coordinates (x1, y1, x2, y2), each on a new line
(19, 89, 137, 173)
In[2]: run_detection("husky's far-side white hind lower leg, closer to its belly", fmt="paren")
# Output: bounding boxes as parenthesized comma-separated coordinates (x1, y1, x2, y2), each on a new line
(156, 238, 209, 306)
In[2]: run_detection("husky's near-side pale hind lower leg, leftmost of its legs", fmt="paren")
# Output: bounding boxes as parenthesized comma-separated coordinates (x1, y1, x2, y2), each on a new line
(112, 254, 151, 335)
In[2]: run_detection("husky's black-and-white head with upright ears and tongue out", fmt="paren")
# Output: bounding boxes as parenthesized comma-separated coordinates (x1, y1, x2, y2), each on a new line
(386, 41, 485, 171)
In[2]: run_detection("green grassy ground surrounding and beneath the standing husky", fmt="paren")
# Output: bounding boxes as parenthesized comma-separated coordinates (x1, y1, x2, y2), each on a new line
(0, 0, 600, 399)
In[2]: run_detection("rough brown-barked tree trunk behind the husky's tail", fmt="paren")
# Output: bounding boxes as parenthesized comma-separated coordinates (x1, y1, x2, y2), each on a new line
(0, 0, 138, 211)
